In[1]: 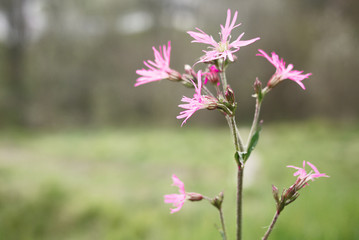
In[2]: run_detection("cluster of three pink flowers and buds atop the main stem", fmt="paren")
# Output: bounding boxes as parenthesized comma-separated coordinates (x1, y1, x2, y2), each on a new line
(135, 9, 259, 126)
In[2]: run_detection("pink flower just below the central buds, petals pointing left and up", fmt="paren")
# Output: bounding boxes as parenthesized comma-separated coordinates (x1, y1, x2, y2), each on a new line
(177, 71, 218, 126)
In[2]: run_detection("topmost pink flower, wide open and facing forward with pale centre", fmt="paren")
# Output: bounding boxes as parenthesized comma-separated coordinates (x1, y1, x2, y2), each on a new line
(187, 9, 260, 62)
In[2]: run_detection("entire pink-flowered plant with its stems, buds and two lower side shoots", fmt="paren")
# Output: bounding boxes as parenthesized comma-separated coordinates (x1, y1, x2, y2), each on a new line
(135, 9, 328, 239)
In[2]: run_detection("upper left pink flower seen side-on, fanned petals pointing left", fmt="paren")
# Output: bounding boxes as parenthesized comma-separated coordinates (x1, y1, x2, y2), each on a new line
(135, 41, 181, 87)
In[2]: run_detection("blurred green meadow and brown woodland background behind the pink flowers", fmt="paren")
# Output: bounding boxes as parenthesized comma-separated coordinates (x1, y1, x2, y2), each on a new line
(0, 0, 359, 240)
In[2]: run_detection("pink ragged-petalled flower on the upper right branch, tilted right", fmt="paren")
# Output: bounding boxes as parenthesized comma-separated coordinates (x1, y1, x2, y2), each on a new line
(257, 49, 312, 90)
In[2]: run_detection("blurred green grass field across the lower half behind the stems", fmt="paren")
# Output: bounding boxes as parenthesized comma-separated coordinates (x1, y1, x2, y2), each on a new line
(0, 121, 359, 240)
